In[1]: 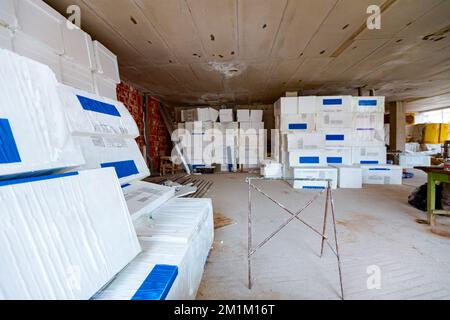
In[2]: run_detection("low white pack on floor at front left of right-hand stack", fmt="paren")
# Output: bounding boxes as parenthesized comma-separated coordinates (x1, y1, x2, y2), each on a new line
(292, 167, 338, 189)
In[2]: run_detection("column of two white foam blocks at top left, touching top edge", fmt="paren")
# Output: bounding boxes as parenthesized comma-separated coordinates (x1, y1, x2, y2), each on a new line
(13, 0, 66, 81)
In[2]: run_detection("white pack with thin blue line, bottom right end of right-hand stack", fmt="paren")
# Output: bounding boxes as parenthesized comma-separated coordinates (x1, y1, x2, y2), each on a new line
(361, 165, 403, 185)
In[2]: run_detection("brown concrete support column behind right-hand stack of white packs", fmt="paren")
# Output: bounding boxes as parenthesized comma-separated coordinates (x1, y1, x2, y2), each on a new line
(388, 101, 406, 151)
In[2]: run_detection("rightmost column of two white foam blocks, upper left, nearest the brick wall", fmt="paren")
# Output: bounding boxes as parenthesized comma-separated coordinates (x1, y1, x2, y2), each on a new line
(93, 41, 120, 99)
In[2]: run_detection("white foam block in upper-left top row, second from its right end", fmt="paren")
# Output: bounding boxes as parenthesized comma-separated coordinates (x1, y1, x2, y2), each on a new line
(62, 21, 95, 71)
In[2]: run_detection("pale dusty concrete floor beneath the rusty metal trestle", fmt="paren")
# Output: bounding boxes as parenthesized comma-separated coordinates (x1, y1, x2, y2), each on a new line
(197, 174, 450, 300)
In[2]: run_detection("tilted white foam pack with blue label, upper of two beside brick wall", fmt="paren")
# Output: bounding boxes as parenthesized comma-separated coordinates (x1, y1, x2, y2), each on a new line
(58, 85, 139, 138)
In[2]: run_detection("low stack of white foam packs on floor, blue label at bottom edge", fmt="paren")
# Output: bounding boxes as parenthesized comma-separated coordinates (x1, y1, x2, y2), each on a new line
(95, 199, 214, 300)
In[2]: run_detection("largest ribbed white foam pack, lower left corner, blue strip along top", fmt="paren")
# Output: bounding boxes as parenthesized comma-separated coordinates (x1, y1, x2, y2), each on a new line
(0, 169, 141, 300)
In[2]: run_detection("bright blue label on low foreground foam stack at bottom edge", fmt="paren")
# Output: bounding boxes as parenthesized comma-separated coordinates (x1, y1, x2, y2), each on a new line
(131, 264, 178, 300)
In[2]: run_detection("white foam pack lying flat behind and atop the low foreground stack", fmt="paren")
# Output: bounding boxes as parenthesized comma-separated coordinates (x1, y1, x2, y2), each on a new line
(122, 181, 175, 220)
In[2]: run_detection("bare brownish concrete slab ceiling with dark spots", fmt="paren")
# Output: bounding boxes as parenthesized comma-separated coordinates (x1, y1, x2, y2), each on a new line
(46, 0, 450, 107)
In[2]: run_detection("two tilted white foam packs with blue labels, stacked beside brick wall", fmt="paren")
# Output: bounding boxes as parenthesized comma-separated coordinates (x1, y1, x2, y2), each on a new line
(58, 85, 150, 184)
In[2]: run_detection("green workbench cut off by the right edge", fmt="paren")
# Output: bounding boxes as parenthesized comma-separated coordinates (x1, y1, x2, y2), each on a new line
(415, 166, 450, 226)
